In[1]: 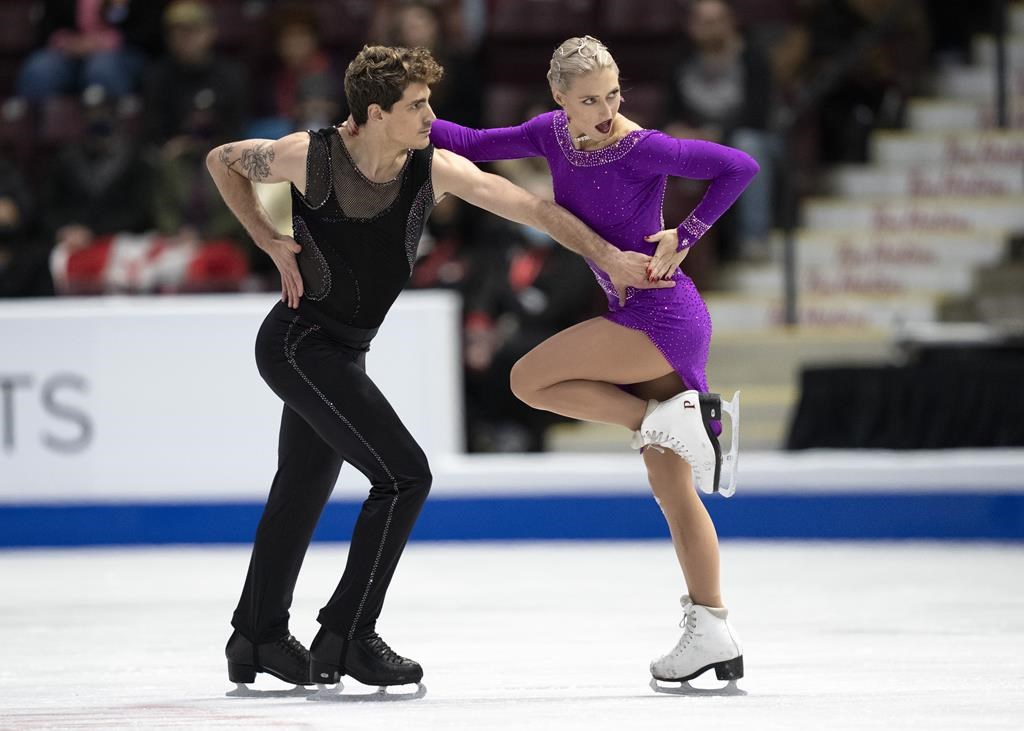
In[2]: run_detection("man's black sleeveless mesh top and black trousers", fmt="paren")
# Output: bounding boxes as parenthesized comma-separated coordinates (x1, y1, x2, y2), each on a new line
(231, 127, 434, 643)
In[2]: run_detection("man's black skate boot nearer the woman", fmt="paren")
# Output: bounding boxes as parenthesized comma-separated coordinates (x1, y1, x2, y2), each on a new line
(309, 627, 423, 687)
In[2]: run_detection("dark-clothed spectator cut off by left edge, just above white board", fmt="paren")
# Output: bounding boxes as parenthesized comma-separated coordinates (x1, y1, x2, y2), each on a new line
(0, 159, 53, 297)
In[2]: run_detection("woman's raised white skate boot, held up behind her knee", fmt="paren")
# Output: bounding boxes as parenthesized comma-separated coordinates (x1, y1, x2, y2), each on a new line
(630, 391, 739, 498)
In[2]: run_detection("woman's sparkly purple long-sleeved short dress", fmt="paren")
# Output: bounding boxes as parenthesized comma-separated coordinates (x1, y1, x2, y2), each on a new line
(430, 111, 758, 391)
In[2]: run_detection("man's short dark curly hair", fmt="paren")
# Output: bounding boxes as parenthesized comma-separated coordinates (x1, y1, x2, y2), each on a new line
(345, 46, 444, 125)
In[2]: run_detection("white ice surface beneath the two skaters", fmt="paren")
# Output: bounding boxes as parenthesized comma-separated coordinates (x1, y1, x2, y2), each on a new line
(0, 542, 1024, 731)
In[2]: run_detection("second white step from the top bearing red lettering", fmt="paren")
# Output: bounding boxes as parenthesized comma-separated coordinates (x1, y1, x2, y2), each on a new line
(828, 163, 1024, 198)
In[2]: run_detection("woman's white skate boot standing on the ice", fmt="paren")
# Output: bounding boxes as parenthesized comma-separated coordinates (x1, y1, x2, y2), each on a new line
(650, 594, 744, 695)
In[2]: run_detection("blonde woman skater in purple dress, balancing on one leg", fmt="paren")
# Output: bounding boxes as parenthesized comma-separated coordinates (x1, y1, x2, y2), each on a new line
(430, 36, 758, 685)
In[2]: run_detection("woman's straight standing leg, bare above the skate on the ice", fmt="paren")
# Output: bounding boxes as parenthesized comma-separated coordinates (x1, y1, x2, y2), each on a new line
(631, 373, 725, 607)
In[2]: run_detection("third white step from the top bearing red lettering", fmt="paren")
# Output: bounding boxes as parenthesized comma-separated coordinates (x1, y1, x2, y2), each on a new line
(803, 196, 1024, 233)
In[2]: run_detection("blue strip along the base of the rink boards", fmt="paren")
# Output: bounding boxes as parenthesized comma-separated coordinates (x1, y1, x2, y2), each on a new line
(0, 490, 1024, 547)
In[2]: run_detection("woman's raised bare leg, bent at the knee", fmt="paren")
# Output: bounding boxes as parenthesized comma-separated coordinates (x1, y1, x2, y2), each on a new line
(510, 317, 673, 429)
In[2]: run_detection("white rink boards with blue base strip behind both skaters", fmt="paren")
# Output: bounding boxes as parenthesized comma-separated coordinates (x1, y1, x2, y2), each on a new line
(6, 292, 1024, 547)
